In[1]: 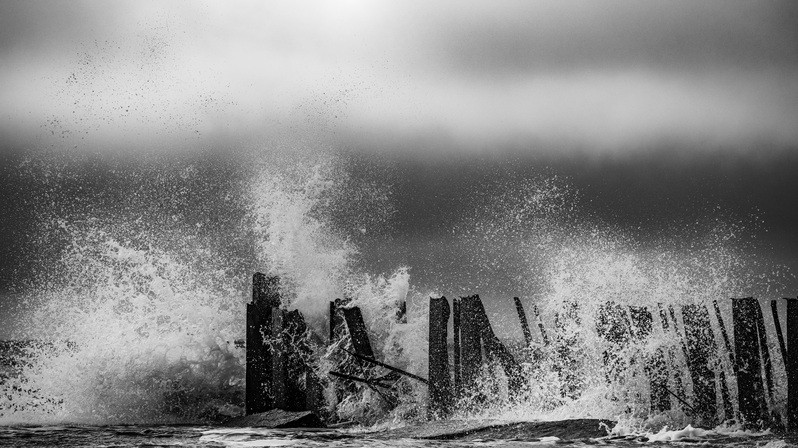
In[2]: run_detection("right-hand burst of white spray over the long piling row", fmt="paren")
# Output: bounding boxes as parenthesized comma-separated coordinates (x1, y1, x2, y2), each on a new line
(434, 174, 783, 429)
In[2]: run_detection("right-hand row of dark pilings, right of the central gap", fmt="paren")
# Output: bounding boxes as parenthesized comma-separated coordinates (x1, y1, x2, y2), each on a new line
(428, 296, 798, 431)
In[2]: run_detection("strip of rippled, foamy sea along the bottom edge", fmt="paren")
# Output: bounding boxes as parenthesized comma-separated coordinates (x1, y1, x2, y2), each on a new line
(0, 425, 798, 448)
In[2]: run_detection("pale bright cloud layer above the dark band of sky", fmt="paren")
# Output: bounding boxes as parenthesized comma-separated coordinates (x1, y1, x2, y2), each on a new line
(0, 0, 798, 154)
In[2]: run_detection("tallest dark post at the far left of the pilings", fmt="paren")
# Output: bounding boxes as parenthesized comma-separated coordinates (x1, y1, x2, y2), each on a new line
(245, 272, 280, 415)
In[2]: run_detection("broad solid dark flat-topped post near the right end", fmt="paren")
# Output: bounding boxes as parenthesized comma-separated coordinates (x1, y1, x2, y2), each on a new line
(732, 297, 767, 426)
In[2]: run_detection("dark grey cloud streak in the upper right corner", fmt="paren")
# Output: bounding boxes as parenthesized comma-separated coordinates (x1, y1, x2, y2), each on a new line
(399, 0, 798, 76)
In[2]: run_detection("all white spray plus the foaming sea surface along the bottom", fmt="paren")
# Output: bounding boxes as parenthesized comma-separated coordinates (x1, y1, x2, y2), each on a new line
(0, 152, 798, 447)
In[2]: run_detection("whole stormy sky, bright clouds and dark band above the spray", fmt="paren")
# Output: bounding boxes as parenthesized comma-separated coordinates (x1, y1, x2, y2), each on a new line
(0, 0, 798, 328)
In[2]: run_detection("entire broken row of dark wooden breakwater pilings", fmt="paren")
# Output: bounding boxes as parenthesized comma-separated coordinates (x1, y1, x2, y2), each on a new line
(246, 274, 798, 431)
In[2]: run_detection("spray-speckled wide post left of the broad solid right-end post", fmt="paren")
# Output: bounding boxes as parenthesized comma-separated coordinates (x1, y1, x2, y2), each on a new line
(682, 305, 718, 425)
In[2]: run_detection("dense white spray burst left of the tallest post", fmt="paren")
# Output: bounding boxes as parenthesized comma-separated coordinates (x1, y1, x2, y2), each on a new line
(2, 226, 244, 424)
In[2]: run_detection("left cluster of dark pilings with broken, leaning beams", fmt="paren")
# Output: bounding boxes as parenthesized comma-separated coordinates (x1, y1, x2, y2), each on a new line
(245, 273, 412, 415)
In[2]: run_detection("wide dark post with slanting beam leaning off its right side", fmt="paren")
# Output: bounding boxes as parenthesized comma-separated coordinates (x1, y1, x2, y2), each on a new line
(460, 295, 482, 394)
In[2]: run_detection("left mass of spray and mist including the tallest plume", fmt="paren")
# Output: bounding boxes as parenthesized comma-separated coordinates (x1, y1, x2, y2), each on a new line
(0, 159, 412, 424)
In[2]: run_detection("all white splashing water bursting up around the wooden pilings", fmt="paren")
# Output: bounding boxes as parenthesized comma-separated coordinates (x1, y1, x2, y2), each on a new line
(0, 151, 783, 437)
